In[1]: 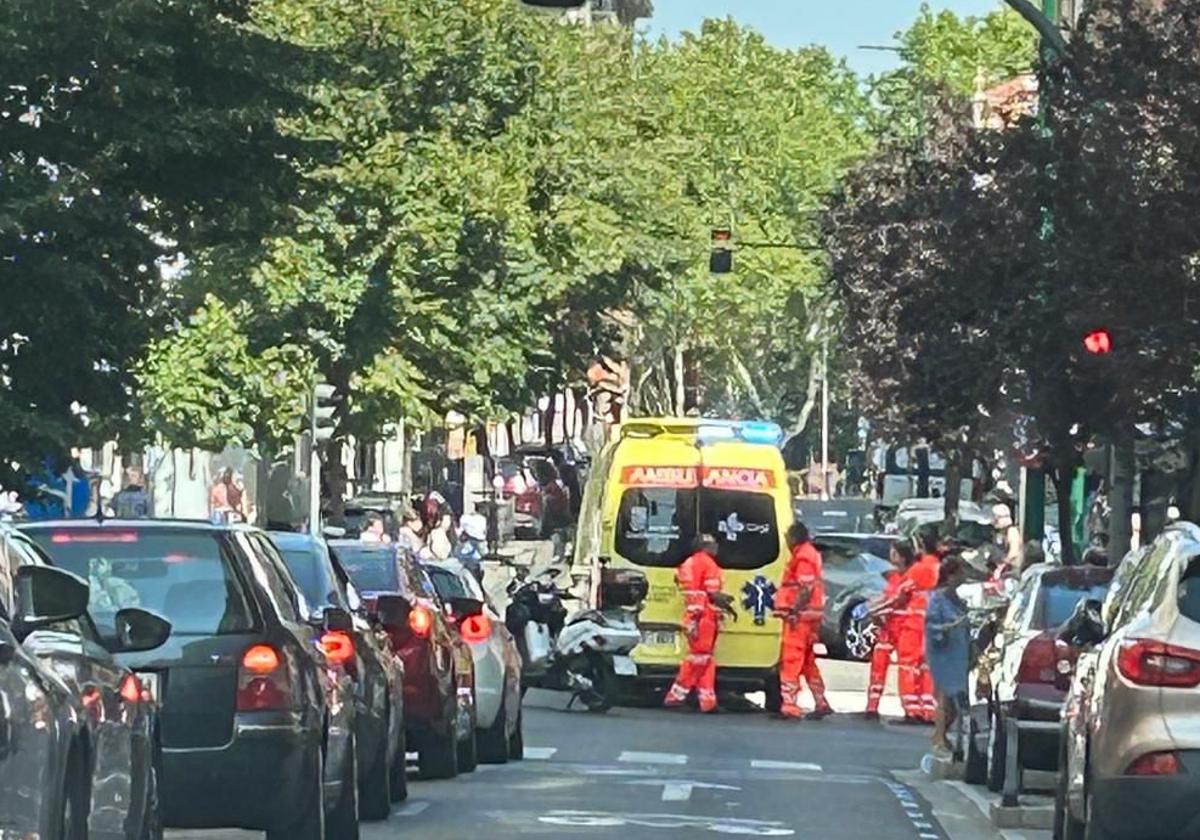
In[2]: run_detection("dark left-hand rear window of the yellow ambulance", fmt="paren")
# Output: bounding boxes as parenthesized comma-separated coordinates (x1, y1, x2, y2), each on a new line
(616, 487, 698, 568)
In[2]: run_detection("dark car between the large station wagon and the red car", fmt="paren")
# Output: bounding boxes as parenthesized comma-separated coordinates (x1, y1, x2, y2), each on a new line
(270, 532, 408, 820)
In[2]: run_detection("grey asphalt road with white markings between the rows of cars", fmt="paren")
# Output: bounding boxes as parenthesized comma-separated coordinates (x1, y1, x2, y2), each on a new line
(170, 691, 995, 840)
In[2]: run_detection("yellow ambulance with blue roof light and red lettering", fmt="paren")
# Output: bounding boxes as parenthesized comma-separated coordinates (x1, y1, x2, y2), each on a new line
(574, 418, 793, 703)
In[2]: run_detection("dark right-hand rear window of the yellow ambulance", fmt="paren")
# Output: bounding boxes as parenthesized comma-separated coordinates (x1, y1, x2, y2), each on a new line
(700, 488, 781, 569)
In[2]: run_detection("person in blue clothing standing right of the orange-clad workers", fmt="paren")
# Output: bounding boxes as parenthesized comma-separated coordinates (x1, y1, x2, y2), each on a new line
(925, 557, 971, 752)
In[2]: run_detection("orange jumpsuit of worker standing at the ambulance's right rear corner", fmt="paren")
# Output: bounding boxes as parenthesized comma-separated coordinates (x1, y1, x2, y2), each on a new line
(775, 542, 829, 718)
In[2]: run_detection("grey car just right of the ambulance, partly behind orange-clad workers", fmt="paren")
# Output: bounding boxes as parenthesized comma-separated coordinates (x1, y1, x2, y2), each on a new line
(812, 534, 896, 661)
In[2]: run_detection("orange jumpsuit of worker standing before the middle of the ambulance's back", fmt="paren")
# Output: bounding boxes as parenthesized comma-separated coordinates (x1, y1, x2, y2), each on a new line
(665, 551, 725, 712)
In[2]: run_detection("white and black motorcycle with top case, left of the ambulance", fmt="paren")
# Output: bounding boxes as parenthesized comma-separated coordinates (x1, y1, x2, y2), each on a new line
(505, 564, 648, 713)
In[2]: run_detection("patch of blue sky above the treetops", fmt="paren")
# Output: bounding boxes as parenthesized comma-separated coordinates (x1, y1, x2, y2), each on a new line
(643, 0, 1000, 73)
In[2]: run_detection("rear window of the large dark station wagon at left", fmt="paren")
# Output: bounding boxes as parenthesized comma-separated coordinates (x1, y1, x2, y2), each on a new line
(30, 528, 254, 636)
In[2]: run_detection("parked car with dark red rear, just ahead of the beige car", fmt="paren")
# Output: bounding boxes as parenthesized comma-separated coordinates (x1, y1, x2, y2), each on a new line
(966, 563, 1112, 792)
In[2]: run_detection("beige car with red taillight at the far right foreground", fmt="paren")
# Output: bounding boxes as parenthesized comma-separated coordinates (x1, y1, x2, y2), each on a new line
(1056, 523, 1200, 840)
